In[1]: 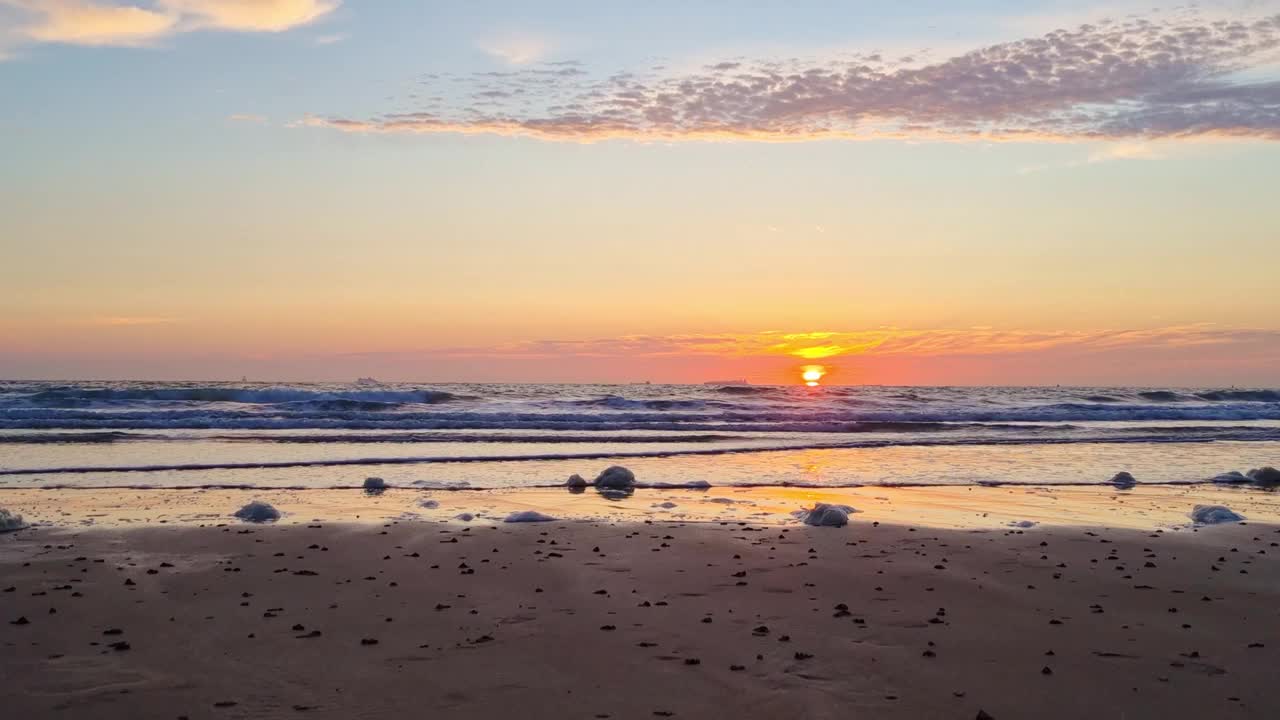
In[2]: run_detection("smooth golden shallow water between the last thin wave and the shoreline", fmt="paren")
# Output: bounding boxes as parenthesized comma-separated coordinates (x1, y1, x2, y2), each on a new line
(0, 442, 1280, 488)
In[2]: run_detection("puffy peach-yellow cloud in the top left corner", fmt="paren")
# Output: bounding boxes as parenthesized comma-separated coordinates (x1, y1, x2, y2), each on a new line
(0, 0, 342, 47)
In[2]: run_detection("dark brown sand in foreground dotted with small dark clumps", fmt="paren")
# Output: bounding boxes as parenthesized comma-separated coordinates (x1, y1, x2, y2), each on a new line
(0, 504, 1280, 720)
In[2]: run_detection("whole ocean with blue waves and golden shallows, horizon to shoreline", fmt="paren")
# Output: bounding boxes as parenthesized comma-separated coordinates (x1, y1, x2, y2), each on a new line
(0, 382, 1280, 488)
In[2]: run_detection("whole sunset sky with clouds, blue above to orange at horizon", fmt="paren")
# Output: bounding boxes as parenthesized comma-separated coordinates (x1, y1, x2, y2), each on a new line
(0, 0, 1280, 387)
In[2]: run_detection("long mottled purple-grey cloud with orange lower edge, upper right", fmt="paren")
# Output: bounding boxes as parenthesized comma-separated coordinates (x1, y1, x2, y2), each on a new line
(298, 12, 1280, 142)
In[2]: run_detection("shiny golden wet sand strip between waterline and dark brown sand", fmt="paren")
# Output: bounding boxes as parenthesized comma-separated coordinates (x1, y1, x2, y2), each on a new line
(0, 484, 1280, 532)
